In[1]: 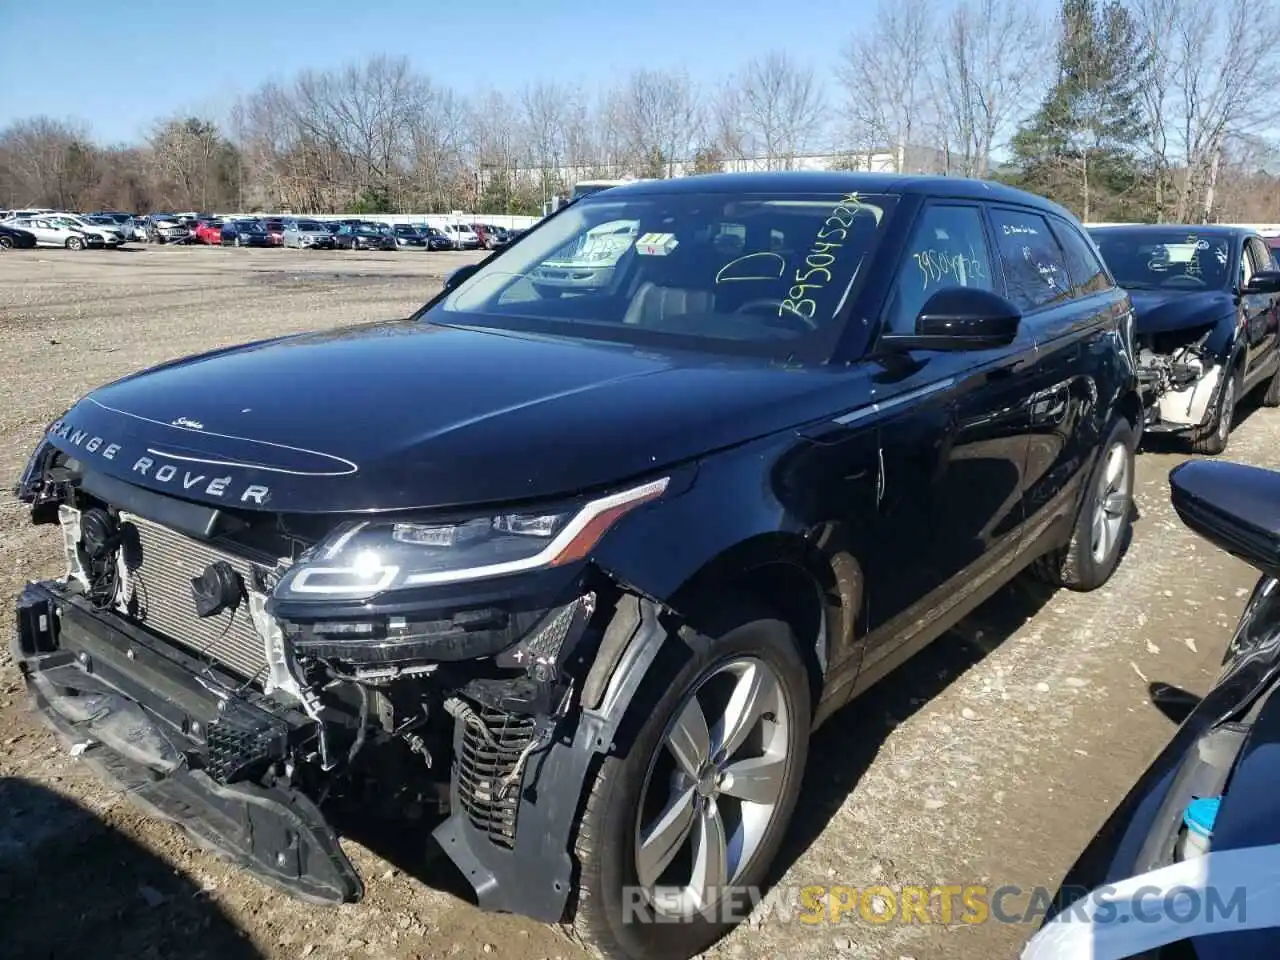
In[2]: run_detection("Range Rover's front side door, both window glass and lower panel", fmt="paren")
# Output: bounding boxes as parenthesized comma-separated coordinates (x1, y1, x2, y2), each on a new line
(844, 201, 1034, 686)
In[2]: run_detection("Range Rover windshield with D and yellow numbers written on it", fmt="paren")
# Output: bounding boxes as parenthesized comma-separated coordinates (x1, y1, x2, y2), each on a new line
(429, 192, 895, 358)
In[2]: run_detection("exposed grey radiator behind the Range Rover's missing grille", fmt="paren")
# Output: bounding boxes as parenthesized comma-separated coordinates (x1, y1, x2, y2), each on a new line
(120, 512, 273, 678)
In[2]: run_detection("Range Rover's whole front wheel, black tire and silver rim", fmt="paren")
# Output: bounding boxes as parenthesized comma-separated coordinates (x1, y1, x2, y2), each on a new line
(573, 604, 810, 960)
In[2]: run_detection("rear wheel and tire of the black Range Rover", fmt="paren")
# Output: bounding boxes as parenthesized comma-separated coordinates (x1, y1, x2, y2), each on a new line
(1030, 417, 1137, 593)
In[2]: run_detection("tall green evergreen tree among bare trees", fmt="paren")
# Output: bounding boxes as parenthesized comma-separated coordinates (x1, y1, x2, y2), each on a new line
(1012, 0, 1149, 220)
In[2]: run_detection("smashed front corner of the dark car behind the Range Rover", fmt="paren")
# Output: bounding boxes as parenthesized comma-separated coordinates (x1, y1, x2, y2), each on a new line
(1138, 324, 1228, 433)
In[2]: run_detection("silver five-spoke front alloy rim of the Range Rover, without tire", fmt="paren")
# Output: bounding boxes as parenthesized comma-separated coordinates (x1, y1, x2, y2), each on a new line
(635, 657, 791, 916)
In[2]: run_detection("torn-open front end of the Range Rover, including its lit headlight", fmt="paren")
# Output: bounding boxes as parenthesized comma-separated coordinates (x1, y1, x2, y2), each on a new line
(14, 443, 666, 922)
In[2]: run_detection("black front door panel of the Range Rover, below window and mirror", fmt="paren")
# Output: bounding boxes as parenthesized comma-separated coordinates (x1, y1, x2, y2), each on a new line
(863, 335, 1034, 675)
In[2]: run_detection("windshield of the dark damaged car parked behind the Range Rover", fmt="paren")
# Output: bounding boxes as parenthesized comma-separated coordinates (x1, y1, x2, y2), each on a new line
(1092, 229, 1231, 289)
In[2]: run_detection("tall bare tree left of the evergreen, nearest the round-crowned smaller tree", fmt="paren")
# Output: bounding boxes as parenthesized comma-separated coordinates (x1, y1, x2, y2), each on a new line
(840, 0, 933, 170)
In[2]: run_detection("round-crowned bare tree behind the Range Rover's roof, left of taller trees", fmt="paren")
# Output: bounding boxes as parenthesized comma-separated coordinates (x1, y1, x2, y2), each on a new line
(740, 51, 824, 170)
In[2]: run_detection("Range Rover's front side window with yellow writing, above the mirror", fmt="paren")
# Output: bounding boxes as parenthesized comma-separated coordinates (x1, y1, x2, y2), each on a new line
(887, 205, 995, 333)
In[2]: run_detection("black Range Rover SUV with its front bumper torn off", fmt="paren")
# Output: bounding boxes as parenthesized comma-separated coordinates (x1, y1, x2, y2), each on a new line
(15, 174, 1142, 960)
